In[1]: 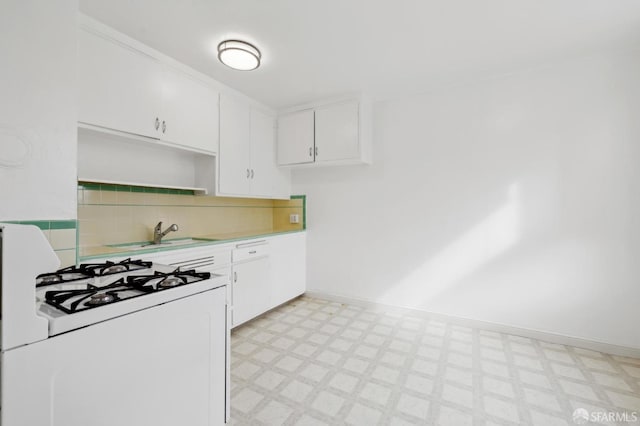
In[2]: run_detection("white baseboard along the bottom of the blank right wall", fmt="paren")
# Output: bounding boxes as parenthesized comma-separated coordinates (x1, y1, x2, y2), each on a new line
(304, 290, 640, 358)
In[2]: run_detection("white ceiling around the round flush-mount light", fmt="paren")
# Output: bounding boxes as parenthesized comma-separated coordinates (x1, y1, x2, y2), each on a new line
(80, 0, 640, 108)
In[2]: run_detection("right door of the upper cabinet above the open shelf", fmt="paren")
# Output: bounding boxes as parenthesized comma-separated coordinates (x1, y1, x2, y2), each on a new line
(160, 66, 218, 154)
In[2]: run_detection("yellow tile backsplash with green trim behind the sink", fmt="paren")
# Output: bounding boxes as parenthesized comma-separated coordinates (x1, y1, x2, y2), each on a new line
(78, 183, 305, 256)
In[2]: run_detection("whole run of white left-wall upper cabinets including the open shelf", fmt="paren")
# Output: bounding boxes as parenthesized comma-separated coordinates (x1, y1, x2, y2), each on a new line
(78, 15, 290, 199)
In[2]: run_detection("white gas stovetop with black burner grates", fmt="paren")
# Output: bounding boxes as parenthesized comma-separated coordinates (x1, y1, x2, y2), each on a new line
(36, 259, 227, 335)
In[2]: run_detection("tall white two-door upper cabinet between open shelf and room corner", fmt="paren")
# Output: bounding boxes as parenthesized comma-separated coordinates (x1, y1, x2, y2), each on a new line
(218, 95, 291, 199)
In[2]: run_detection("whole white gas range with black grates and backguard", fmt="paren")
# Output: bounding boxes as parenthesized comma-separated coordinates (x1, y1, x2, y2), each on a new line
(0, 225, 228, 426)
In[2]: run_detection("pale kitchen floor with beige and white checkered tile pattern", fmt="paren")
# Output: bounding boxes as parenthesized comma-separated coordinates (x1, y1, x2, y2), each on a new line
(231, 297, 640, 426)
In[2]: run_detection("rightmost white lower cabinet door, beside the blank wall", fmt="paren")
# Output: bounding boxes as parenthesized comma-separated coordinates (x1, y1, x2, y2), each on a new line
(269, 232, 307, 309)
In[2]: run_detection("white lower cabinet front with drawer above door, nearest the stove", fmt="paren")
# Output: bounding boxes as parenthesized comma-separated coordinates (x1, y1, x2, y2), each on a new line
(231, 240, 271, 327)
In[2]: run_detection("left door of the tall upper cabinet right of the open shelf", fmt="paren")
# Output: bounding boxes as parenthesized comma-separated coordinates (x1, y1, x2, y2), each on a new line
(218, 95, 251, 195)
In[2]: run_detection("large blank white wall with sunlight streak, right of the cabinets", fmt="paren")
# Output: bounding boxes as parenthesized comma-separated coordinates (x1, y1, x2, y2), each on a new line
(293, 53, 640, 348)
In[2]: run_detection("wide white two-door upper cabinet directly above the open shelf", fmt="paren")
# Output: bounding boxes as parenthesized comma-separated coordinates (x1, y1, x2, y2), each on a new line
(78, 28, 218, 154)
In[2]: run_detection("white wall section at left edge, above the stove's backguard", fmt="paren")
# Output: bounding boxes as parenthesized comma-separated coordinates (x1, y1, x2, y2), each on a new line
(0, 0, 77, 220)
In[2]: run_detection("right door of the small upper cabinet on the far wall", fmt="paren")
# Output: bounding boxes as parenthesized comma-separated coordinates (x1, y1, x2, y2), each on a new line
(315, 102, 359, 162)
